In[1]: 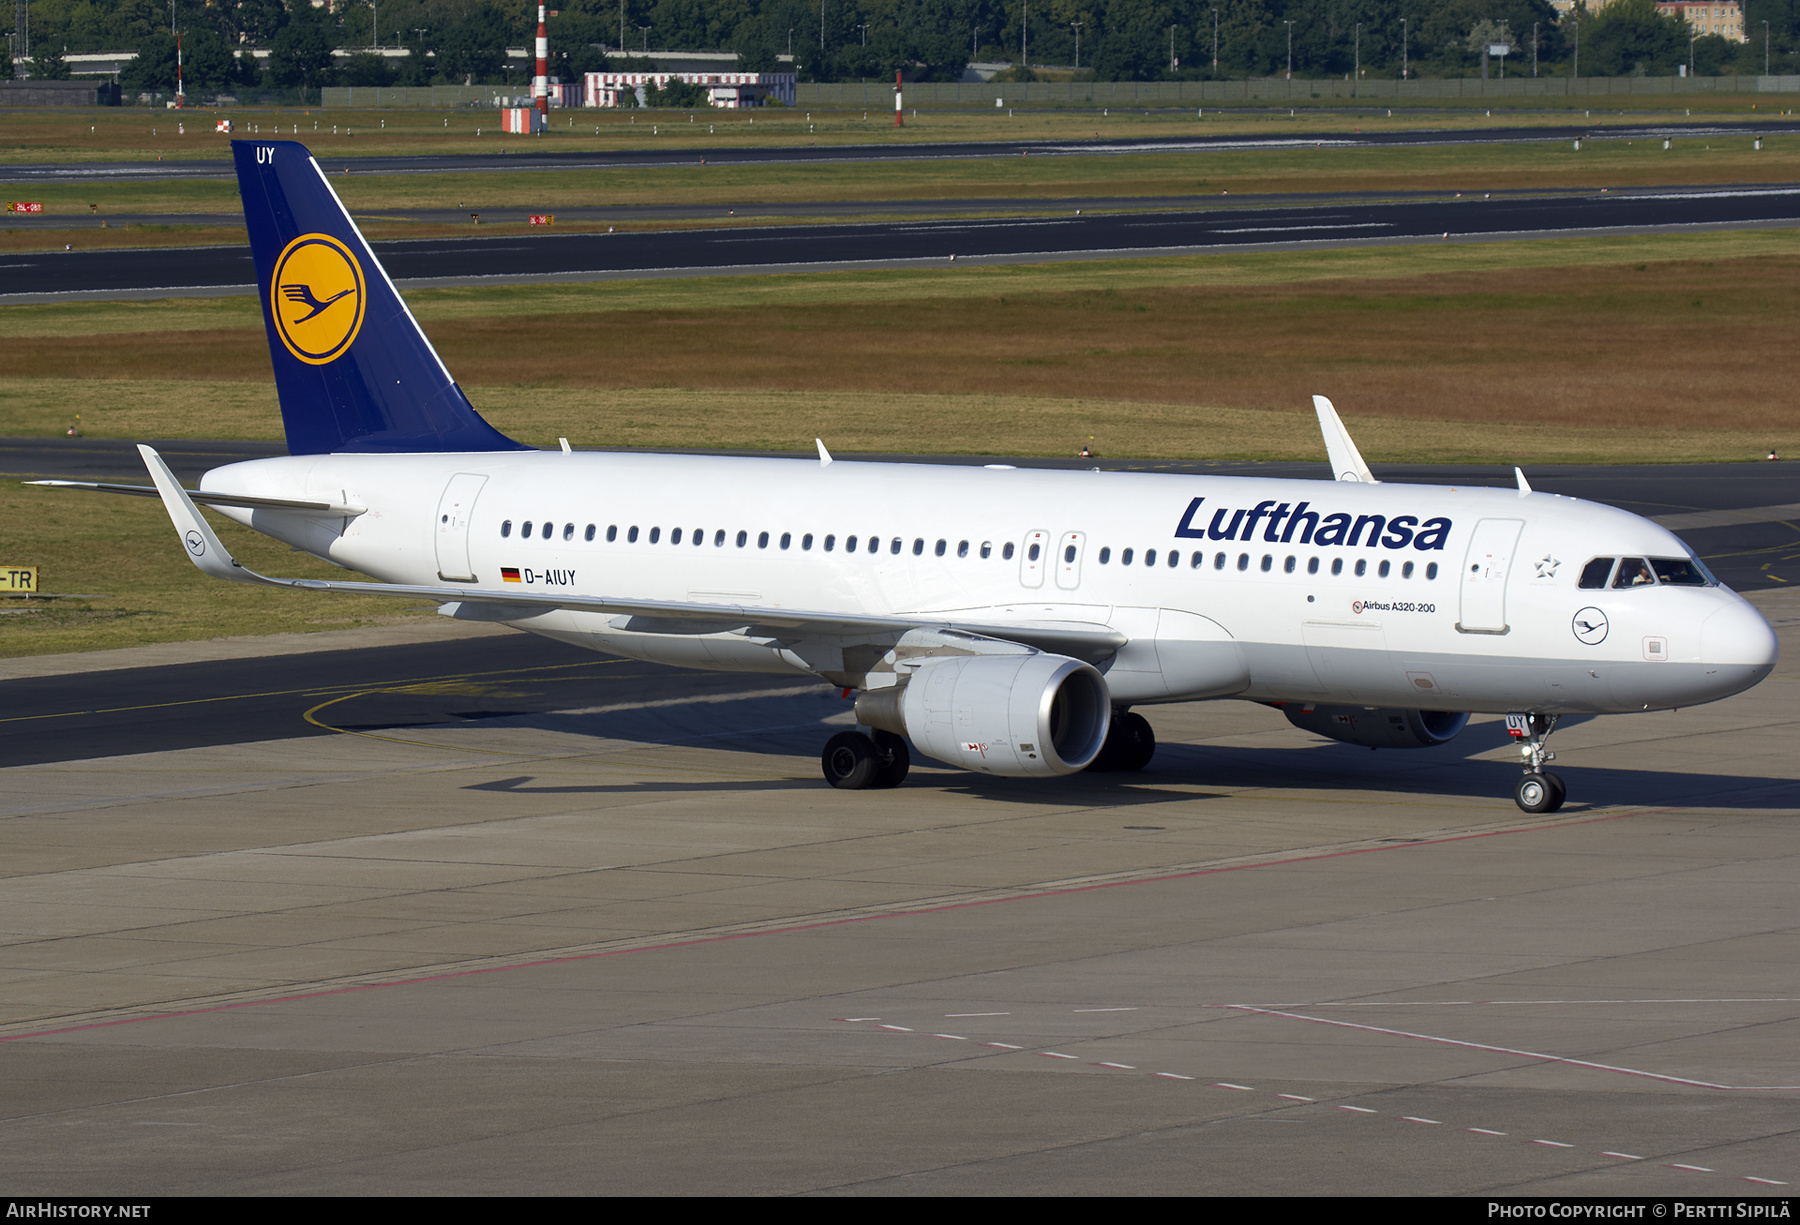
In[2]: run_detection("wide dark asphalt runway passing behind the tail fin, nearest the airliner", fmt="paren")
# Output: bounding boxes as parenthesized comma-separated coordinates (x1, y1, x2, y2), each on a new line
(10, 187, 1800, 304)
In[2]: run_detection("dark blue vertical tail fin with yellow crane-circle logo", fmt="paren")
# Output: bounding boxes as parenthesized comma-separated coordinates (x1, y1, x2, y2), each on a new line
(232, 140, 527, 455)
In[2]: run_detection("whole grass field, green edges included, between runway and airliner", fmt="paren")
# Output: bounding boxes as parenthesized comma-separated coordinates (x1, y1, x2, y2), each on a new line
(0, 232, 1800, 449)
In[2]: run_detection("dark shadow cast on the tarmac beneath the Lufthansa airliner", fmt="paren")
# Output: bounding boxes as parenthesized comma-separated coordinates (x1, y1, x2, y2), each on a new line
(439, 689, 1800, 811)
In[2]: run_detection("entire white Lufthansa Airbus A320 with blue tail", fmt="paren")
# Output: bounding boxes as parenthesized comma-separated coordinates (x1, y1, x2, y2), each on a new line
(41, 142, 1777, 813)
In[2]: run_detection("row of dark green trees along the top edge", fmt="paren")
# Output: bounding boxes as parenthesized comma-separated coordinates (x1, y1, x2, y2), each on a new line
(9, 0, 1800, 94)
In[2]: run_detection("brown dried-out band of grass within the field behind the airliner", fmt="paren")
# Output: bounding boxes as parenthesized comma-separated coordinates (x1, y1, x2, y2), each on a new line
(0, 254, 1800, 438)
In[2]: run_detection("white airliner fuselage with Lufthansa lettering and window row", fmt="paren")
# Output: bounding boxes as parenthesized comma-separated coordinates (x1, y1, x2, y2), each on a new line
(203, 452, 1775, 714)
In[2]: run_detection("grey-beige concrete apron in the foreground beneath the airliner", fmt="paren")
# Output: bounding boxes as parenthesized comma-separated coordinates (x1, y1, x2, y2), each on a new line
(0, 592, 1800, 1196)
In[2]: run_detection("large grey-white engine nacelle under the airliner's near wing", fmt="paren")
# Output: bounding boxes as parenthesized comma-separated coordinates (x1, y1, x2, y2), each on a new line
(857, 651, 1112, 779)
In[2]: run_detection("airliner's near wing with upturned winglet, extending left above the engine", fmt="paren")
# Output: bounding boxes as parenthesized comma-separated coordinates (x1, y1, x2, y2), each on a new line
(137, 444, 1129, 662)
